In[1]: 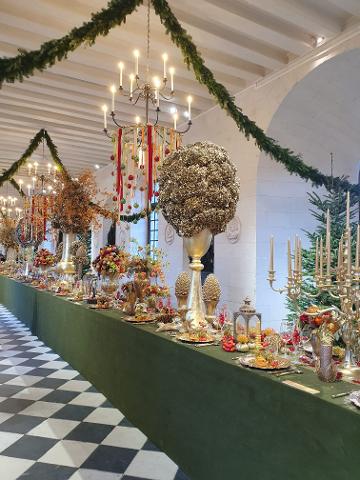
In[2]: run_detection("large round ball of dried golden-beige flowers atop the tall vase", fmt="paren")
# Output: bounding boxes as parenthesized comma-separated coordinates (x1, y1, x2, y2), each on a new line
(159, 142, 239, 237)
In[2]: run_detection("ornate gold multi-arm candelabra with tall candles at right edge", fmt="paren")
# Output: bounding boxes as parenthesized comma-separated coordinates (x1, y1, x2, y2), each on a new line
(268, 193, 360, 377)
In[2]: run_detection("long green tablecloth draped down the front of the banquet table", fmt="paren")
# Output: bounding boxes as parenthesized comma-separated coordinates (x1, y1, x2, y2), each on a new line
(0, 276, 360, 480)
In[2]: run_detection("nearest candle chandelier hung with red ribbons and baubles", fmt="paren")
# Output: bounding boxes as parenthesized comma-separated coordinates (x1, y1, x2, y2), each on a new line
(102, 1, 193, 219)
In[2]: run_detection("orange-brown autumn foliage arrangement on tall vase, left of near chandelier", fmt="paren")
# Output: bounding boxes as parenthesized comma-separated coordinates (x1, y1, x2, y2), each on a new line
(52, 171, 98, 234)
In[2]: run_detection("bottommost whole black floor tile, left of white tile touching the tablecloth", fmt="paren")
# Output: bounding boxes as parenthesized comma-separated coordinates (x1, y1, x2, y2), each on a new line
(81, 445, 138, 473)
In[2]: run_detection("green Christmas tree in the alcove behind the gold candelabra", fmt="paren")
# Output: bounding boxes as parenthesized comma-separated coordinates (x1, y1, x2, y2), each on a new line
(286, 182, 359, 321)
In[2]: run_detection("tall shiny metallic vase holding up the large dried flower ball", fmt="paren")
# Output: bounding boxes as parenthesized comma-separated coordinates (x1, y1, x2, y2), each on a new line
(184, 229, 212, 329)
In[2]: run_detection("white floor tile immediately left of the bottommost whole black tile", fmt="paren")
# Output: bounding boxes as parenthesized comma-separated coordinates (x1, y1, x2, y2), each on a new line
(39, 440, 97, 468)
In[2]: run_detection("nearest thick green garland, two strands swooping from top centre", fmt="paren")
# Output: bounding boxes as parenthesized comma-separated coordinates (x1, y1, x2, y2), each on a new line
(0, 0, 360, 195)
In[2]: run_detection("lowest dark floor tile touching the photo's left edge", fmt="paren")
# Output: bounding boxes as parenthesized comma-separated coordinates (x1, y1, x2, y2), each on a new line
(1, 435, 58, 460)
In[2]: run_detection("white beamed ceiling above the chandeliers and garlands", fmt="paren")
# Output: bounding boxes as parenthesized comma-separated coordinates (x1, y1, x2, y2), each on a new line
(0, 0, 360, 174)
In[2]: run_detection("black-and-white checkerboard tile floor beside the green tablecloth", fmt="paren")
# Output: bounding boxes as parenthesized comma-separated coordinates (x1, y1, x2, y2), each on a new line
(0, 305, 188, 480)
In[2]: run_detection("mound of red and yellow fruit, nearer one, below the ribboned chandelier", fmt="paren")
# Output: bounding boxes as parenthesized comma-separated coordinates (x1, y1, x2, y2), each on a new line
(92, 245, 130, 276)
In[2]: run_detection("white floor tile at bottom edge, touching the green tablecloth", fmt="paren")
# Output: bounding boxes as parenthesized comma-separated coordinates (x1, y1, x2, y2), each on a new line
(125, 450, 177, 480)
